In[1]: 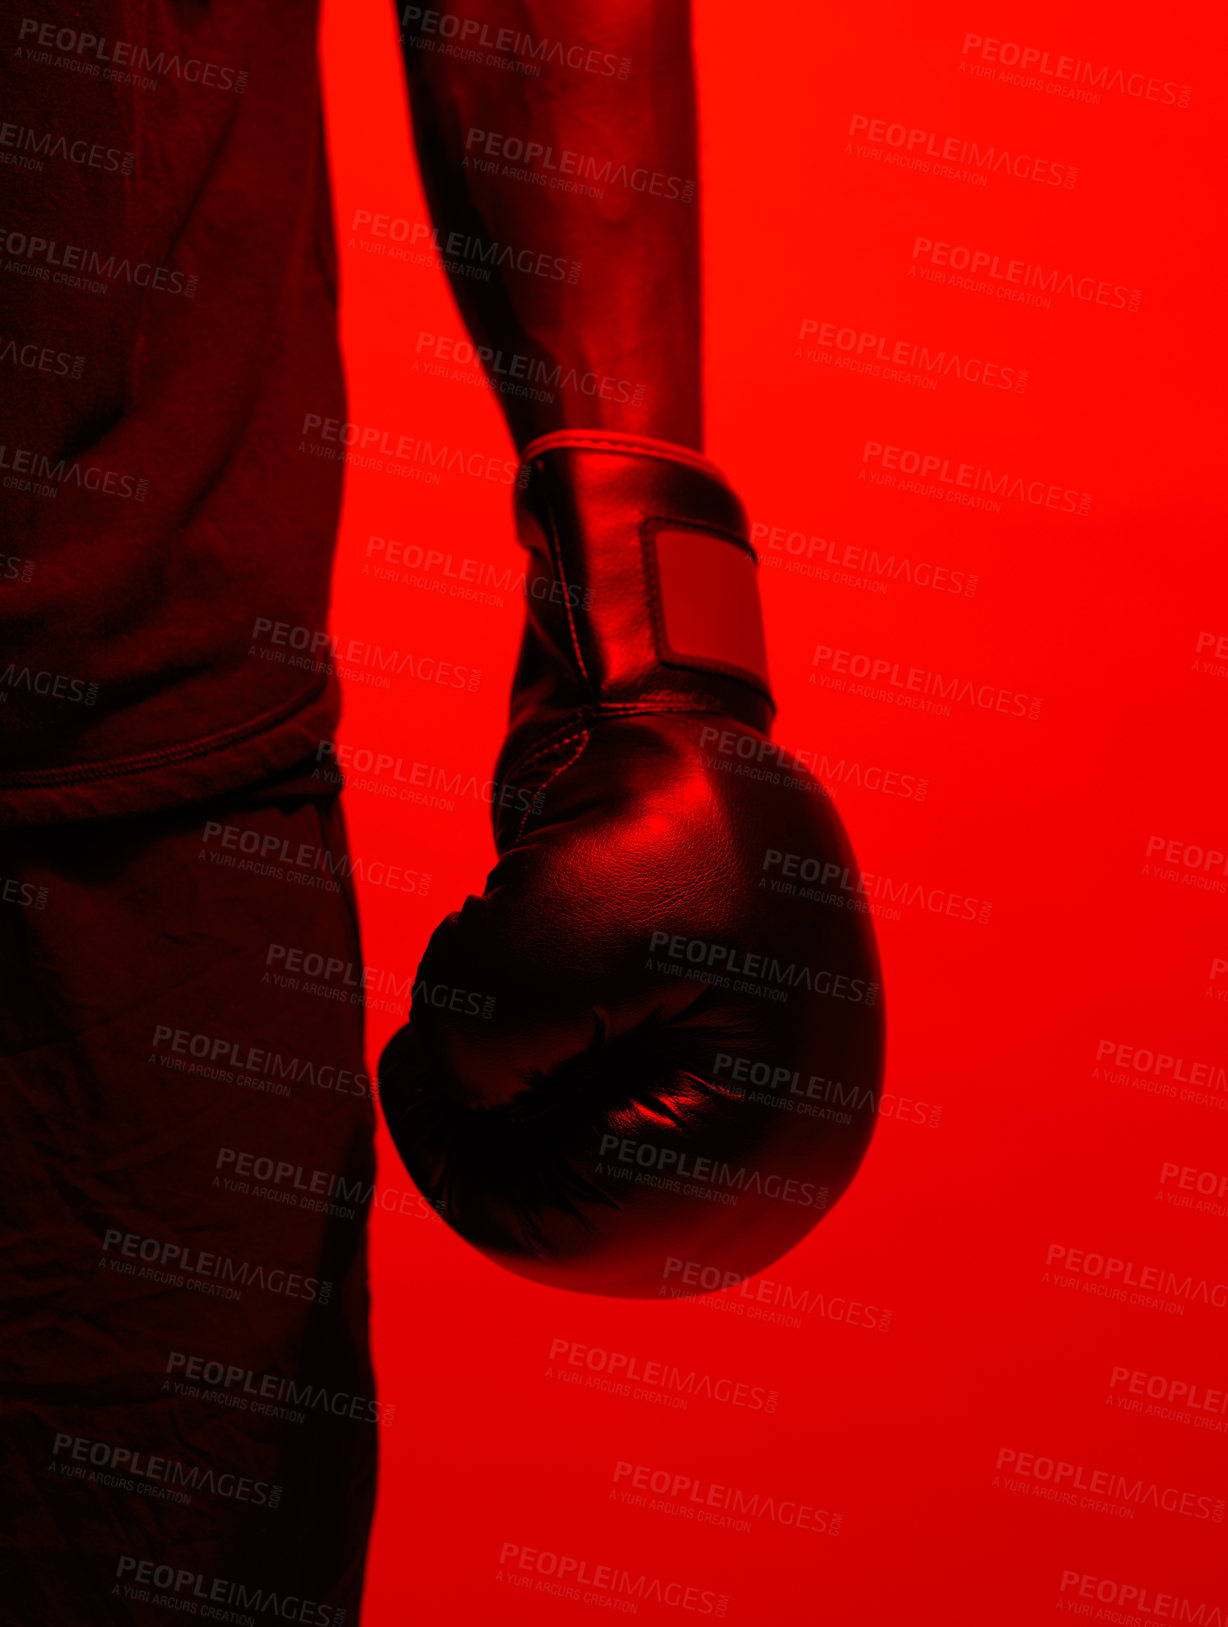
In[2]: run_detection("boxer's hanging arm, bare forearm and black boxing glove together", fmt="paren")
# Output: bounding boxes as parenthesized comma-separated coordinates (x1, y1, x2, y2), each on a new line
(379, 0, 883, 1298)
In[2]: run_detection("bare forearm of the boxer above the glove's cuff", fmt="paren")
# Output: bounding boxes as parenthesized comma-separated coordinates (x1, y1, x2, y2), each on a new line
(398, 0, 703, 449)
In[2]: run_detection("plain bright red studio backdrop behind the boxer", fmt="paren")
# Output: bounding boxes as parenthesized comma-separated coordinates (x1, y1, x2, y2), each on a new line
(320, 0, 1228, 1627)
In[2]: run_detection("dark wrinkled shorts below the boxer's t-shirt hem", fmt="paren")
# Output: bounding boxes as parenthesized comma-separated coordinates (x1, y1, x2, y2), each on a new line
(0, 786, 384, 1627)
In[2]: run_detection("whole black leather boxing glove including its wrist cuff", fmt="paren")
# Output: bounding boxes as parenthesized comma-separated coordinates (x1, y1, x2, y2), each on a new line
(379, 431, 883, 1297)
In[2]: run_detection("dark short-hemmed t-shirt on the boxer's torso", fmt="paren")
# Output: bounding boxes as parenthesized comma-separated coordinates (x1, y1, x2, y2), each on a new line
(0, 0, 345, 822)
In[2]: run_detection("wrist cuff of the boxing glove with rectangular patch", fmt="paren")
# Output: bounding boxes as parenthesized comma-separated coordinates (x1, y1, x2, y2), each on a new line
(514, 430, 774, 732)
